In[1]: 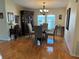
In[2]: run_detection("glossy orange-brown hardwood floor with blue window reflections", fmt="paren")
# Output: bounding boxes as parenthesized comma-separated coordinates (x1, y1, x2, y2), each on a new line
(0, 36, 79, 59)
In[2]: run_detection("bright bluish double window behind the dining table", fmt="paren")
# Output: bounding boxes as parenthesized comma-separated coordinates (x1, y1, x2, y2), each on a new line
(38, 15, 55, 30)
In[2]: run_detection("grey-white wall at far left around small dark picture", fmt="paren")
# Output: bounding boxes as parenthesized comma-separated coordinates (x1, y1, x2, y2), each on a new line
(0, 0, 9, 40)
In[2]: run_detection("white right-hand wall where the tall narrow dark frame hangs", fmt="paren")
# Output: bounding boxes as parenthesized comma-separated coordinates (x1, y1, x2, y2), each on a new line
(64, 0, 79, 56)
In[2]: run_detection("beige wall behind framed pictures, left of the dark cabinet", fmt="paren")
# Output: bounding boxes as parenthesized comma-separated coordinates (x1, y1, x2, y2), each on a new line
(5, 0, 23, 28)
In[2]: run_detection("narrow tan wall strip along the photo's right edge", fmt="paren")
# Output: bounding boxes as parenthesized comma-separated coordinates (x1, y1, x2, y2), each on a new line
(74, 2, 79, 57)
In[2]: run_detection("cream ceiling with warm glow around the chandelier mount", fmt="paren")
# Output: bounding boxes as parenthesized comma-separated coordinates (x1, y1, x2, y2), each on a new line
(13, 0, 68, 9)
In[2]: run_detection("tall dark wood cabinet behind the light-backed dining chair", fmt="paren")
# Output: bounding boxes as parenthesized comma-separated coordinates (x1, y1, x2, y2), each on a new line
(20, 10, 34, 35)
